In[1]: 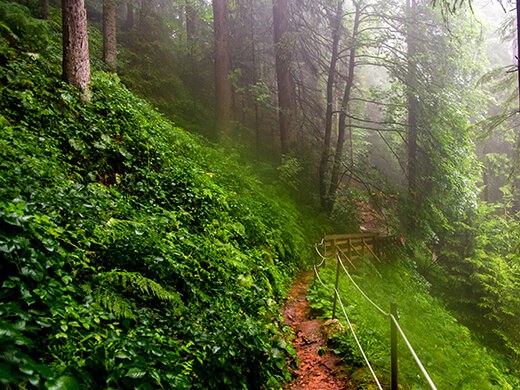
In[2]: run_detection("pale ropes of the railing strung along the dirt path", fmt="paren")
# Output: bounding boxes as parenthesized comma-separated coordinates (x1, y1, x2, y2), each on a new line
(314, 240, 437, 390)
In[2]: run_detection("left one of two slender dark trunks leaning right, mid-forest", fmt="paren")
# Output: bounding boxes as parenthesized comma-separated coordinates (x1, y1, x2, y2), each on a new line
(318, 0, 343, 210)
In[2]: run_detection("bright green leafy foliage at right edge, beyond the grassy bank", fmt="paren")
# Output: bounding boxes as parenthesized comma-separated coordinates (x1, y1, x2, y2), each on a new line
(443, 205, 520, 361)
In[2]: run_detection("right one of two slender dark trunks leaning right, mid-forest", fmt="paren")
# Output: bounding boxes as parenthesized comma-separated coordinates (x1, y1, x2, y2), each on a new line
(326, 2, 361, 214)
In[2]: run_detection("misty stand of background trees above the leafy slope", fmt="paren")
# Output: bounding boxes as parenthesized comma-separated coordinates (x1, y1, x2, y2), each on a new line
(54, 0, 494, 230)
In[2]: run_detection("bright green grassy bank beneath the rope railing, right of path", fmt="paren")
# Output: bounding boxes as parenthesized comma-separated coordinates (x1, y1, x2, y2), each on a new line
(308, 260, 520, 389)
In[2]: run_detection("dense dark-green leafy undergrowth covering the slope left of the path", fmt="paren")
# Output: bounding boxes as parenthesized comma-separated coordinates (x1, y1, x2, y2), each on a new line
(0, 2, 305, 389)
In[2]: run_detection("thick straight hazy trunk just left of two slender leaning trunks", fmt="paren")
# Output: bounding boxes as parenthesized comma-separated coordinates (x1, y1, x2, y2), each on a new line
(273, 0, 296, 154)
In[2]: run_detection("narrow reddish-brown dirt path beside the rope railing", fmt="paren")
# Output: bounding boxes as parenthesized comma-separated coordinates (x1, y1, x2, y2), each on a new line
(283, 272, 352, 390)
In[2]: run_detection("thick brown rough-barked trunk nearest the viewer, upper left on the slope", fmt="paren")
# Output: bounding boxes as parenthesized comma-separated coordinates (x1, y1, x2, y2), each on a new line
(62, 0, 90, 100)
